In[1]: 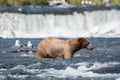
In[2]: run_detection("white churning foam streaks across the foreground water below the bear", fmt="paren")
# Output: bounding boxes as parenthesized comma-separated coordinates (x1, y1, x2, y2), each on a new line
(9, 62, 120, 80)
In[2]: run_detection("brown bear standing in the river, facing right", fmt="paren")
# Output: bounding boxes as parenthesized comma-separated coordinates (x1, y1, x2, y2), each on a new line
(36, 37, 93, 59)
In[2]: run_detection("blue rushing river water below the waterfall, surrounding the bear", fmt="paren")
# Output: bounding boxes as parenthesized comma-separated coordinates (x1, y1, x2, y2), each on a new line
(0, 38, 120, 80)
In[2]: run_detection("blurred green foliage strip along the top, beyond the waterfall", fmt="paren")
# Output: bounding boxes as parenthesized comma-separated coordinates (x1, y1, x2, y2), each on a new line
(0, 0, 120, 6)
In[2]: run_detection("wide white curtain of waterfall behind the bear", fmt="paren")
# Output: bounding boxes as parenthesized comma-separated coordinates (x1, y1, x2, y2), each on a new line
(0, 10, 120, 38)
